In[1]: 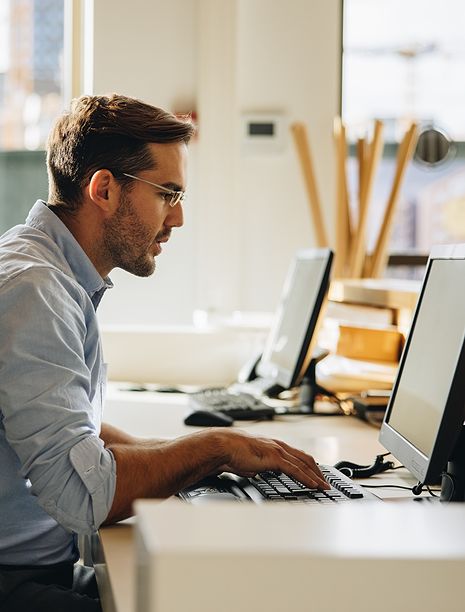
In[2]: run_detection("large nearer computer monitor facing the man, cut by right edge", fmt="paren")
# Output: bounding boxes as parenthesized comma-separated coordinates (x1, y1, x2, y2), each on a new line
(379, 244, 465, 498)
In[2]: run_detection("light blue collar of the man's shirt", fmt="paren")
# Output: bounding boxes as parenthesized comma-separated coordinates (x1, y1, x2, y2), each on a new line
(26, 200, 113, 308)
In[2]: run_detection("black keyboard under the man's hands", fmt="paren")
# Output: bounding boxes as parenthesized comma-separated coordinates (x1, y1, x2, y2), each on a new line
(179, 465, 380, 506)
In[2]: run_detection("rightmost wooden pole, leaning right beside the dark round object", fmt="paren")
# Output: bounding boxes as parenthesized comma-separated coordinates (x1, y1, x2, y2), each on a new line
(368, 123, 418, 278)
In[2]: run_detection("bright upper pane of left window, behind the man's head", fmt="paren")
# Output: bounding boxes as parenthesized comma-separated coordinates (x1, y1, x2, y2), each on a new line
(0, 0, 64, 150)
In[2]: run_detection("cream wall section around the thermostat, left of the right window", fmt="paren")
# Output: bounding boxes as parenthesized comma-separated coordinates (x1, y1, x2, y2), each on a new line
(237, 0, 340, 309)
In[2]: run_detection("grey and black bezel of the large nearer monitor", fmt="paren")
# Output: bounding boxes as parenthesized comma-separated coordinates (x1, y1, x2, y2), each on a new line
(379, 244, 465, 484)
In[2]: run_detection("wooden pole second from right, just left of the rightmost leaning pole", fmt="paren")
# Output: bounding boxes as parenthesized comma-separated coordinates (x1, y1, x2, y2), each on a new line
(349, 120, 384, 278)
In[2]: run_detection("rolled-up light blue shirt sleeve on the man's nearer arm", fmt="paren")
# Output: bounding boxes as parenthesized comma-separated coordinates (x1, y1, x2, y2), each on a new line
(0, 268, 116, 533)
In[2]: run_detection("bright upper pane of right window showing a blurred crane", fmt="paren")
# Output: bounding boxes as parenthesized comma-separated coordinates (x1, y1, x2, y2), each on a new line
(343, 0, 465, 141)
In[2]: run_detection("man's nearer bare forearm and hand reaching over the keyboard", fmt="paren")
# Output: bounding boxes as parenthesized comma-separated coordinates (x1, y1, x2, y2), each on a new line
(105, 428, 329, 524)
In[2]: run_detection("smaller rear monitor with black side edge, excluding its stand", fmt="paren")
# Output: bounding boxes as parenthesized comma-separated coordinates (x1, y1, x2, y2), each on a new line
(257, 249, 333, 389)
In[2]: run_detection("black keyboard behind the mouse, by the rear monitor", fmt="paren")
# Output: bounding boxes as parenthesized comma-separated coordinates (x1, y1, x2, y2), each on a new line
(189, 388, 276, 421)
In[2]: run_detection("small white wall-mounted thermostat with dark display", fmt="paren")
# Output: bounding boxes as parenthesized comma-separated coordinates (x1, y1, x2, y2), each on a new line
(242, 113, 285, 155)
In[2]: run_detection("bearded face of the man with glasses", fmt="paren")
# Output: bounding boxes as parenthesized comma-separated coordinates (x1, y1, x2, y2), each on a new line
(103, 143, 187, 276)
